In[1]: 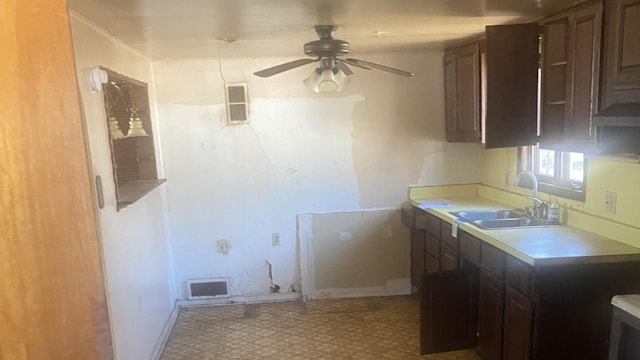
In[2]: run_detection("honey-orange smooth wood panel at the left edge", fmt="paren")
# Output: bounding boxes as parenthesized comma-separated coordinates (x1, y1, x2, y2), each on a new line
(0, 0, 113, 360)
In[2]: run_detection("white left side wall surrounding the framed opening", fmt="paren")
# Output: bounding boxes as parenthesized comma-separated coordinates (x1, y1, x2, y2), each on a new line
(71, 13, 176, 360)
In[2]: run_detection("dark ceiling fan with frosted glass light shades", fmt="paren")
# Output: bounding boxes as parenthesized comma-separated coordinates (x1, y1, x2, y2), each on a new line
(253, 25, 413, 92)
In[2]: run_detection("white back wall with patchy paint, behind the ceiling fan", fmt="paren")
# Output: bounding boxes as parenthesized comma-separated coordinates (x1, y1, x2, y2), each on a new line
(153, 53, 480, 298)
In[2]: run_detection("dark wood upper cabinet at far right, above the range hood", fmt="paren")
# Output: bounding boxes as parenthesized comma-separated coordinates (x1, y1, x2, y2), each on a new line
(601, 0, 640, 109)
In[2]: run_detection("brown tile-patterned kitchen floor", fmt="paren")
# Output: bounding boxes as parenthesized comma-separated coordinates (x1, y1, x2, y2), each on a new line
(161, 296, 481, 360)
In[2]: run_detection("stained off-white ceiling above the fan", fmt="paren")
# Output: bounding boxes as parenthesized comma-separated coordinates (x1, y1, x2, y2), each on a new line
(68, 0, 579, 59)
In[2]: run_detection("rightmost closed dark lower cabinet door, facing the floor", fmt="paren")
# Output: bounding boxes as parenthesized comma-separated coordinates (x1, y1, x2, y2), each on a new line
(502, 287, 533, 360)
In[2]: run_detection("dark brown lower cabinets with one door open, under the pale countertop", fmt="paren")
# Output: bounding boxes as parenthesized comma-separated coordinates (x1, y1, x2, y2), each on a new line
(420, 231, 640, 360)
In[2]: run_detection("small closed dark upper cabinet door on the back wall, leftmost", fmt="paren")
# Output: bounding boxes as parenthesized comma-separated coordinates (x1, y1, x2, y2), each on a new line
(444, 42, 482, 142)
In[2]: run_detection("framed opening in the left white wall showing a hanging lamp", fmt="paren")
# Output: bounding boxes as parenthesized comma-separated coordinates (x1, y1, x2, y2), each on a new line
(102, 69, 165, 210)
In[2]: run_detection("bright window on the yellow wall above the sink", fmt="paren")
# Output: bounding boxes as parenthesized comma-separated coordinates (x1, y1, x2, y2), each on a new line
(520, 145, 586, 201)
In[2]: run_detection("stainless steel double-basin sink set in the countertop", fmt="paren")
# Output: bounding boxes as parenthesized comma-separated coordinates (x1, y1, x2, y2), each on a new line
(451, 209, 560, 230)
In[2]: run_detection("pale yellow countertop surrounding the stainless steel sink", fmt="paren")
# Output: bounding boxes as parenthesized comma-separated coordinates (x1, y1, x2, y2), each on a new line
(410, 196, 640, 266)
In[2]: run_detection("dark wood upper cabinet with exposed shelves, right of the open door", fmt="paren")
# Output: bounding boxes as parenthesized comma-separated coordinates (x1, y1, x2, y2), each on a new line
(540, 2, 603, 152)
